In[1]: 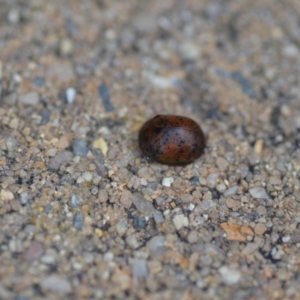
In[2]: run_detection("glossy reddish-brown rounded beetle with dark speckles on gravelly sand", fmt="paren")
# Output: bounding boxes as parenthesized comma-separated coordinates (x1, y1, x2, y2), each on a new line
(139, 115, 205, 165)
